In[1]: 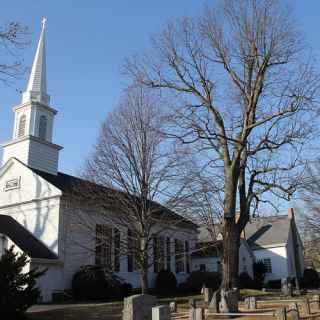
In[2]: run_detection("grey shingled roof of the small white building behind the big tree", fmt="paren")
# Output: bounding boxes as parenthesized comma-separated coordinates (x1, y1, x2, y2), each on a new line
(245, 215, 290, 249)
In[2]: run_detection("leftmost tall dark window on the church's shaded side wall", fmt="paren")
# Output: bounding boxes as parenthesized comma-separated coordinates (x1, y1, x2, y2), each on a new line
(95, 224, 112, 269)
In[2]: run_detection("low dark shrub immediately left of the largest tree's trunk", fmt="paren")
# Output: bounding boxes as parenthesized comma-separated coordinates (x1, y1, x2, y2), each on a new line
(184, 271, 222, 293)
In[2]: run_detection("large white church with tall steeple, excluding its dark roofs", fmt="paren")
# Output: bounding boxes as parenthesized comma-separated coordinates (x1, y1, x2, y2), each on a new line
(0, 19, 197, 301)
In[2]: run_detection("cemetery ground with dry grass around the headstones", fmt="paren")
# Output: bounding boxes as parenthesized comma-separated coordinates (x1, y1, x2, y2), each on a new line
(27, 290, 320, 320)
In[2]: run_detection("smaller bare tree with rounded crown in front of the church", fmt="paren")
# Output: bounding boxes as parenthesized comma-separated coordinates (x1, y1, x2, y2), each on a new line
(70, 87, 196, 293)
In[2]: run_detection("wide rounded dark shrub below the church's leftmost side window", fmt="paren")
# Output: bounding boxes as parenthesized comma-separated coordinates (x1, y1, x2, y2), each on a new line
(72, 266, 128, 301)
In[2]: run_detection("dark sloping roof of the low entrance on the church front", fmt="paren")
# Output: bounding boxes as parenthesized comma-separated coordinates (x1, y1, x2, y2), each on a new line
(0, 214, 58, 259)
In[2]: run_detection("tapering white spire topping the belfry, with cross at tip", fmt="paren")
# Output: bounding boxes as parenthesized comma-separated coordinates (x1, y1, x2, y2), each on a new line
(22, 18, 50, 105)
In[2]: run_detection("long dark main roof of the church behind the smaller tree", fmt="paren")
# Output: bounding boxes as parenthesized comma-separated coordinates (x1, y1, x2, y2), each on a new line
(29, 167, 198, 229)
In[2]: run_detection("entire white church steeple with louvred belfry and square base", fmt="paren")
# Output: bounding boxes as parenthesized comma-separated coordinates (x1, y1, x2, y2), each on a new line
(2, 18, 62, 174)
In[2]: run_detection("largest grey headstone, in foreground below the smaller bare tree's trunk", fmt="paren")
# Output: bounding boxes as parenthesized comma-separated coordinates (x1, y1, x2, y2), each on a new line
(122, 294, 157, 320)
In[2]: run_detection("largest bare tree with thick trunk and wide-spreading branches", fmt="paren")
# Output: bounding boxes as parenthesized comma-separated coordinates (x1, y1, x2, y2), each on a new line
(125, 0, 319, 311)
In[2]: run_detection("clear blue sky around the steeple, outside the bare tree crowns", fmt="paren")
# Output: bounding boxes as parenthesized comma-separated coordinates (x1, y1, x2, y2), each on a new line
(0, 0, 320, 174)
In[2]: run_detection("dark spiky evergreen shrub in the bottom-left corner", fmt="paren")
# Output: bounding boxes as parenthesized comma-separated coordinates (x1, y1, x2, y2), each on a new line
(0, 246, 46, 319)
